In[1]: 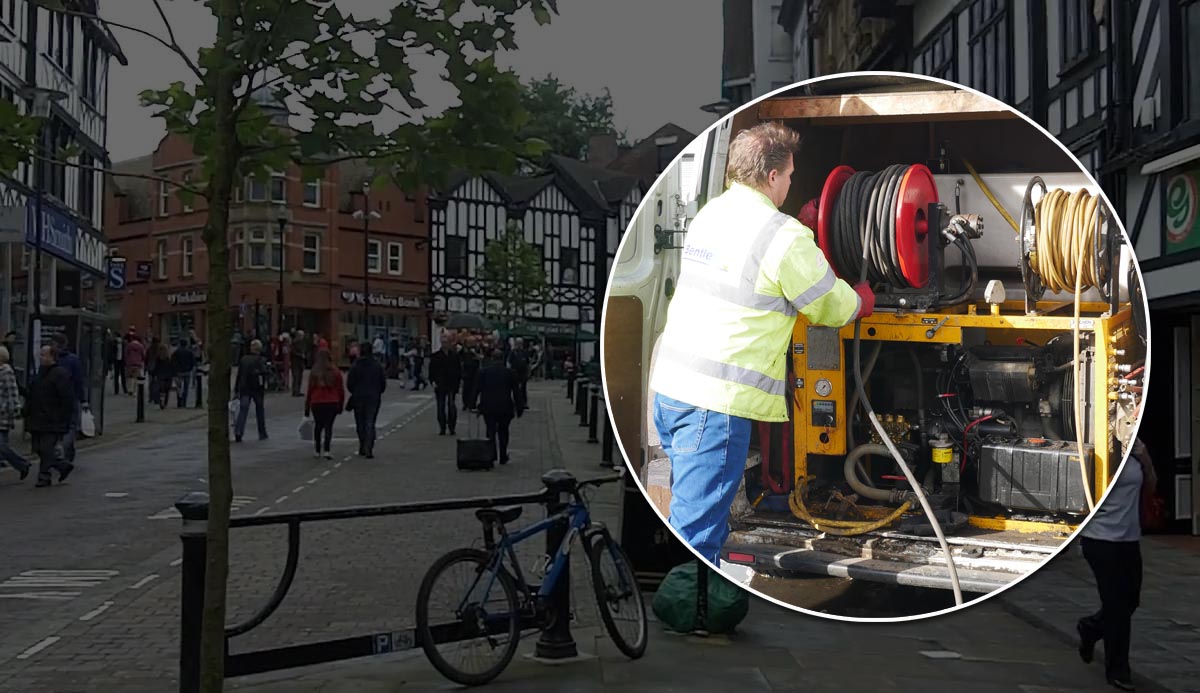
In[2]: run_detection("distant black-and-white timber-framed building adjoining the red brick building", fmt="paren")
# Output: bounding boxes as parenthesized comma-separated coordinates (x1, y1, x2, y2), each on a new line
(430, 156, 644, 361)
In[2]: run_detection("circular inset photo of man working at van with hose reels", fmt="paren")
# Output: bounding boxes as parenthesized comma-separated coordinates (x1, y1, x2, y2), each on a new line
(601, 73, 1150, 620)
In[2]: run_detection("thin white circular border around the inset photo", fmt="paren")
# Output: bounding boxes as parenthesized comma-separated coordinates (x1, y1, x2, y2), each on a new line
(600, 71, 1153, 623)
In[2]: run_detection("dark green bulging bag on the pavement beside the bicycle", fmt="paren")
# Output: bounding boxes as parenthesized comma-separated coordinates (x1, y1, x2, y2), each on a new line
(652, 561, 750, 633)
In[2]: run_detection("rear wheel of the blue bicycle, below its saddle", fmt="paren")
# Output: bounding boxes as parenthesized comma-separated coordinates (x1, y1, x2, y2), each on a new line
(416, 549, 521, 686)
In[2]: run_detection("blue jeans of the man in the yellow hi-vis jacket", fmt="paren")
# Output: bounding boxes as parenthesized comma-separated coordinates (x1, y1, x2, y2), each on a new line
(654, 394, 751, 565)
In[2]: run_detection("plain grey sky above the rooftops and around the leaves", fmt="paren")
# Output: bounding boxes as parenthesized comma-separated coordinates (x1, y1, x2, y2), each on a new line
(101, 0, 721, 161)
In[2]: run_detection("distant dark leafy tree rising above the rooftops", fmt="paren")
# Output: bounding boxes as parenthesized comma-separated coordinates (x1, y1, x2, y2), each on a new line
(521, 74, 628, 158)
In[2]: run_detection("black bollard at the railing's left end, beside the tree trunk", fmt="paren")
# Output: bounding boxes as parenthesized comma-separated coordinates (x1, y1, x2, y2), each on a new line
(175, 492, 209, 693)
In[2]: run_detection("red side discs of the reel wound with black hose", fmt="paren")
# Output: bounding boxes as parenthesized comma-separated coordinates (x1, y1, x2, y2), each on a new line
(816, 163, 938, 289)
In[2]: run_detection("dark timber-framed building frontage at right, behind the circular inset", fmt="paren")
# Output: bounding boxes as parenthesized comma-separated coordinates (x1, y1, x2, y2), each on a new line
(722, 0, 1200, 534)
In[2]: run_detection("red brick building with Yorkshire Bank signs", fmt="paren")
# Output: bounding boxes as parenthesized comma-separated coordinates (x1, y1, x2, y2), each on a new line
(104, 135, 430, 354)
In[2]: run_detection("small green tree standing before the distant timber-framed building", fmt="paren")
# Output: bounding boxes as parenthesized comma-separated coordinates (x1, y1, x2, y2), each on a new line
(482, 222, 546, 325)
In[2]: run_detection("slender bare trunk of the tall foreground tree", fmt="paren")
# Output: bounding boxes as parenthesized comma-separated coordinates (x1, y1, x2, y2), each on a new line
(200, 0, 238, 693)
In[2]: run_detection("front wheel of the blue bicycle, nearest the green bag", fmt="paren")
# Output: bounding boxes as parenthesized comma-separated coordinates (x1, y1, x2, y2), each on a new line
(589, 535, 647, 659)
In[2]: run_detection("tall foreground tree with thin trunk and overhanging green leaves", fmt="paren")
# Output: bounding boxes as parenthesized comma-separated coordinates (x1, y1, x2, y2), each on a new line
(29, 0, 557, 693)
